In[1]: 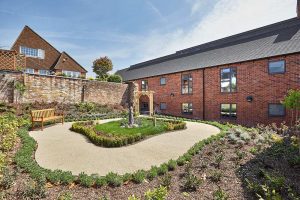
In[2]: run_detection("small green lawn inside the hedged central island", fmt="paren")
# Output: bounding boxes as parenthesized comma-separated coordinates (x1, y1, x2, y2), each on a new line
(95, 119, 167, 137)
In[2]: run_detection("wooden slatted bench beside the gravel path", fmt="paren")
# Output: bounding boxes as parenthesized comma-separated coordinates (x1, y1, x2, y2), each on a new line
(31, 109, 64, 131)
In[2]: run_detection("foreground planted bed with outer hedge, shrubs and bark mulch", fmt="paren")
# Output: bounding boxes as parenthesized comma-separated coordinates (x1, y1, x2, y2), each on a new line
(0, 113, 300, 200)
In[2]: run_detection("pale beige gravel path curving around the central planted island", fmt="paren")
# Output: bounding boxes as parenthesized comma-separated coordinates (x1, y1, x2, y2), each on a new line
(29, 119, 220, 175)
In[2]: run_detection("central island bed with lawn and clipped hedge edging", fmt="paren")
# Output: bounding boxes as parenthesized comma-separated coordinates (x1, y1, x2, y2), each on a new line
(71, 118, 186, 147)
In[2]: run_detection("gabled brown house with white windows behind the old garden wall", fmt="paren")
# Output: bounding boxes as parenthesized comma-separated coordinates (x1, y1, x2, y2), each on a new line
(11, 26, 87, 78)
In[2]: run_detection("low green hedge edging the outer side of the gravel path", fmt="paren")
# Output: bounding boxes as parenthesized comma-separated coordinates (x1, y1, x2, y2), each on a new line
(14, 115, 228, 188)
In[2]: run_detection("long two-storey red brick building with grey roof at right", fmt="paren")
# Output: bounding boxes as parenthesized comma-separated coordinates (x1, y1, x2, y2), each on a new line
(117, 1, 300, 125)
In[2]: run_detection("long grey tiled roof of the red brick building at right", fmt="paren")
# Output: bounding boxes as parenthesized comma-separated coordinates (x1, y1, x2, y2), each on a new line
(117, 18, 300, 81)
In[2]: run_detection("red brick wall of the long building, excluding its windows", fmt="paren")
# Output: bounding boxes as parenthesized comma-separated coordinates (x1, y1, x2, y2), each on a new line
(137, 54, 300, 125)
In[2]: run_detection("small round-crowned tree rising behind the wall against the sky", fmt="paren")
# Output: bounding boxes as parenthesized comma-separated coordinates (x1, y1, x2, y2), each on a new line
(93, 56, 113, 81)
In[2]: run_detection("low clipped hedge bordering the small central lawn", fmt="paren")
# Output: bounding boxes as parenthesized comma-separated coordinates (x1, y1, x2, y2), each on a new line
(70, 120, 186, 148)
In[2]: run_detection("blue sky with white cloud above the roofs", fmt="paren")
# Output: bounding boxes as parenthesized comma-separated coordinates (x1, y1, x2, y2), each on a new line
(0, 0, 297, 77)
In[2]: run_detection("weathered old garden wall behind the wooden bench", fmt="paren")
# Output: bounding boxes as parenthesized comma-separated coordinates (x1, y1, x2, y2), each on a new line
(0, 71, 131, 106)
